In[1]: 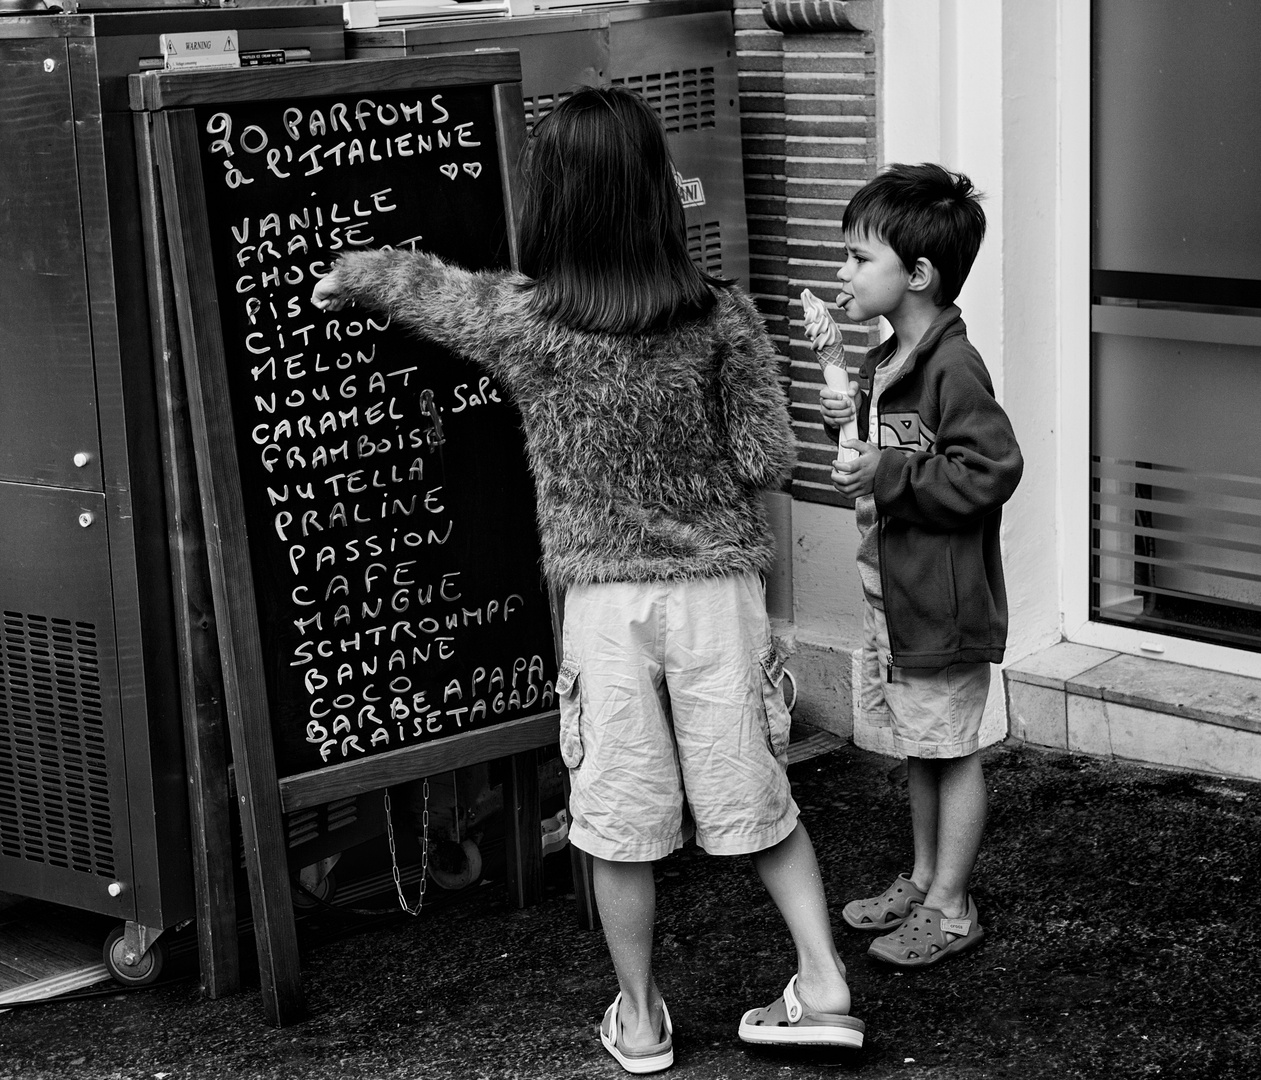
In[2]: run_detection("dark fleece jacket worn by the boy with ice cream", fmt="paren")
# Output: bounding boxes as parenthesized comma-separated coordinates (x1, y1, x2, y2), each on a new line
(859, 304, 1024, 667)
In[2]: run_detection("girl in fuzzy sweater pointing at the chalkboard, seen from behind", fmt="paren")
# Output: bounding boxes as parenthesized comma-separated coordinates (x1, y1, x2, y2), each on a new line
(311, 87, 864, 1072)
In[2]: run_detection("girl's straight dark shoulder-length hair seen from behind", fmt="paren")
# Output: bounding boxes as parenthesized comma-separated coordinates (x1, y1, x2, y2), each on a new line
(520, 87, 730, 333)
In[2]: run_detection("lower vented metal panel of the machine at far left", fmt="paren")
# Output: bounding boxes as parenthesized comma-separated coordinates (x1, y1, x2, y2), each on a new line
(0, 482, 135, 919)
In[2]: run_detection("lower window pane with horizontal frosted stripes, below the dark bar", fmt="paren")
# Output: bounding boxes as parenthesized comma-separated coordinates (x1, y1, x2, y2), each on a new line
(1091, 307, 1261, 651)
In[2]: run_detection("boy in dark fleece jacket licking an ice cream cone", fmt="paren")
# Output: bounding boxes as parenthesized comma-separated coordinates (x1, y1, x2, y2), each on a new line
(807, 164, 1024, 968)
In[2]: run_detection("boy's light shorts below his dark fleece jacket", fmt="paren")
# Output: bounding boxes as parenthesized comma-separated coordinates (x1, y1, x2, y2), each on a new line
(859, 601, 990, 758)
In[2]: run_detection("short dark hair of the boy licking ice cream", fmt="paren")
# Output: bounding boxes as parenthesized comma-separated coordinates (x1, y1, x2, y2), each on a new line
(841, 163, 985, 308)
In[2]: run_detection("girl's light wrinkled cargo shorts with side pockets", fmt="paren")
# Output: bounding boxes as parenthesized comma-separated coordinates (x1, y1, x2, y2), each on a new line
(556, 574, 797, 862)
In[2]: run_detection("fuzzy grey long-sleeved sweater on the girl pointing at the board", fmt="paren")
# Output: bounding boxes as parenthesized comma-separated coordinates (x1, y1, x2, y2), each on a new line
(334, 251, 793, 588)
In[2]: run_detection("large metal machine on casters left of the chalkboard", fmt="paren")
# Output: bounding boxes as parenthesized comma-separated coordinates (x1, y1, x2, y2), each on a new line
(0, 0, 344, 980)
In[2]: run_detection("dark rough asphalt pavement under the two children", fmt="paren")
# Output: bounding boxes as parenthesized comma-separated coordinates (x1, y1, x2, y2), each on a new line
(0, 744, 1261, 1080)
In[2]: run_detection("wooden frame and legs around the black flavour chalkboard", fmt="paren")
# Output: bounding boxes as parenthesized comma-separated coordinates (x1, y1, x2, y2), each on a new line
(130, 50, 569, 1026)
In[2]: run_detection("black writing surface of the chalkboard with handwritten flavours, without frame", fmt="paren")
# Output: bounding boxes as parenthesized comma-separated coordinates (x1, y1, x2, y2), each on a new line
(195, 87, 555, 773)
